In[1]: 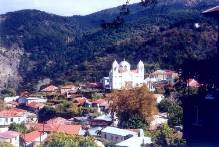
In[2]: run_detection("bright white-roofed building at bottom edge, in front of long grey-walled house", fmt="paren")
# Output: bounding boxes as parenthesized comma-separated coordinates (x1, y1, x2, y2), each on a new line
(116, 136, 152, 147)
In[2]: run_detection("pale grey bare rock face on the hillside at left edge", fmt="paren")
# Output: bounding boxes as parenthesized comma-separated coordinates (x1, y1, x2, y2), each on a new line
(0, 45, 23, 90)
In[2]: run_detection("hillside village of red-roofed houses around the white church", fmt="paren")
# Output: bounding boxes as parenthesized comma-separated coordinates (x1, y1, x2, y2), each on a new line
(0, 60, 200, 147)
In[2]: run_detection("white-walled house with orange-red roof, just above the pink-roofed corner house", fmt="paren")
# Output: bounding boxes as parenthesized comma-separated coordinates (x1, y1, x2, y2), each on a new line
(0, 108, 27, 126)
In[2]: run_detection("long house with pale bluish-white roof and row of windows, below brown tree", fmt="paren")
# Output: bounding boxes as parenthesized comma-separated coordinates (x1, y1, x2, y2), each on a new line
(101, 126, 138, 143)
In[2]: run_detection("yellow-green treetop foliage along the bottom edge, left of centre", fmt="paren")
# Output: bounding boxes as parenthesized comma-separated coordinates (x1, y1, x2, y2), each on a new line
(43, 133, 97, 147)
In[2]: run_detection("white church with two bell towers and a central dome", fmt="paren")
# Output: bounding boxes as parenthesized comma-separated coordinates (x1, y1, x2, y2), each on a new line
(102, 60, 144, 90)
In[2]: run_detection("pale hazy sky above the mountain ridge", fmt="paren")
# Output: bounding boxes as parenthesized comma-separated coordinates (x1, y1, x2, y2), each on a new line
(0, 0, 140, 16)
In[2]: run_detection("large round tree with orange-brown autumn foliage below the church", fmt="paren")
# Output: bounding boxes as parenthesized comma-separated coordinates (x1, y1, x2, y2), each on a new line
(109, 85, 157, 127)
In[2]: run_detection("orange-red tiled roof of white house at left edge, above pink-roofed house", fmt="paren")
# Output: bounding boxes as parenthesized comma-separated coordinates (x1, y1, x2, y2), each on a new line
(0, 108, 26, 117)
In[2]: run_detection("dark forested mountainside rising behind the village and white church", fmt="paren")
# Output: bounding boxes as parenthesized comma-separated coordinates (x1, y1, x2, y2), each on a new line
(0, 0, 218, 90)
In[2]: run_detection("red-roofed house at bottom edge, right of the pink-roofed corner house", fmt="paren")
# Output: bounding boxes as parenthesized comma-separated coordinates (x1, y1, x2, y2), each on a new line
(22, 131, 48, 147)
